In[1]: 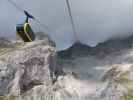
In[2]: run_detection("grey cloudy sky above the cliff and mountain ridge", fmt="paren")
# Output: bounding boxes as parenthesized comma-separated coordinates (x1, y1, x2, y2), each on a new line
(0, 0, 133, 50)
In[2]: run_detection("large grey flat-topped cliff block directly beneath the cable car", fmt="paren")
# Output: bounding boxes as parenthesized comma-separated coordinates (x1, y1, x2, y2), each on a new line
(0, 40, 61, 96)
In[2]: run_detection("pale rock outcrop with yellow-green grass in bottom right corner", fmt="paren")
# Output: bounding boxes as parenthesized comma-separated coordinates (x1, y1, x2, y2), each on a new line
(100, 64, 133, 100)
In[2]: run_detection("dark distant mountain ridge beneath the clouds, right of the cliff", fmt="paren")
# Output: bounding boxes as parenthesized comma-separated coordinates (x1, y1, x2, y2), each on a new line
(58, 36, 133, 58)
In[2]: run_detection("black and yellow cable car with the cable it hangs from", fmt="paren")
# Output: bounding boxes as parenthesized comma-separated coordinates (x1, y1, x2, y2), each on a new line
(7, 0, 50, 42)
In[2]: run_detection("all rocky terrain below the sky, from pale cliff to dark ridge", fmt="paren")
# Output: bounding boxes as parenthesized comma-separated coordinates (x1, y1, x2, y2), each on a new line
(0, 37, 133, 100)
